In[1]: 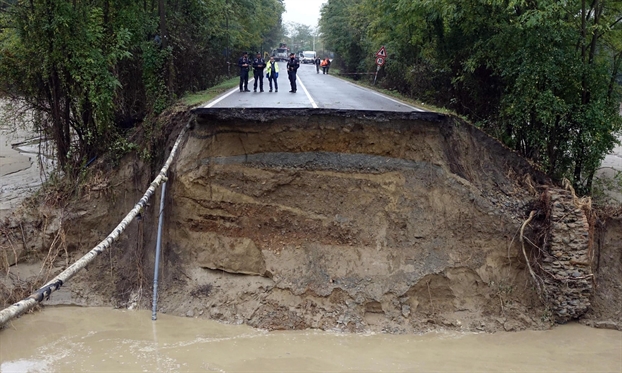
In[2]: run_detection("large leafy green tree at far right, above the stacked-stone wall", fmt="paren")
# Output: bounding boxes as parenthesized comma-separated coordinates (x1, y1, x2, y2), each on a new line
(478, 1, 622, 193)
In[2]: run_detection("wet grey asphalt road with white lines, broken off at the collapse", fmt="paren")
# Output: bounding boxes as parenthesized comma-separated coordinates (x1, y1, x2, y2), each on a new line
(203, 62, 424, 112)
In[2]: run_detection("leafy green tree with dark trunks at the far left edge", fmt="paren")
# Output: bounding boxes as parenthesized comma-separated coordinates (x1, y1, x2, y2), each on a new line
(0, 0, 129, 171)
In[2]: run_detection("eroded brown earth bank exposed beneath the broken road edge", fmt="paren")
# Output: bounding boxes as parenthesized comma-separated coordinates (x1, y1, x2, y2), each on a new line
(1, 109, 622, 332)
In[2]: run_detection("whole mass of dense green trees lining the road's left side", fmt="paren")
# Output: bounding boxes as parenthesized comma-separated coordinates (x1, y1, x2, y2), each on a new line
(0, 0, 284, 174)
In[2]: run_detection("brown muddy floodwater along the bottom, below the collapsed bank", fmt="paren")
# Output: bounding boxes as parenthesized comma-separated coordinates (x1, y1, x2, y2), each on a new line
(0, 307, 622, 373)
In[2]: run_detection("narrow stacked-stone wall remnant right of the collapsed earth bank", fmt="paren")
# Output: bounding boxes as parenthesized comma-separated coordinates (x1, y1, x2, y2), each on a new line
(540, 189, 593, 323)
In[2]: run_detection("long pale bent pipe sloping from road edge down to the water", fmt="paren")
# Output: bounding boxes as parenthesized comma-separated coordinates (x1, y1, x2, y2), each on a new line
(0, 117, 194, 328)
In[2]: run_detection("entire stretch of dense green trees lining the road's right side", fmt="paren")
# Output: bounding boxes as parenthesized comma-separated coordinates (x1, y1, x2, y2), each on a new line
(320, 0, 622, 193)
